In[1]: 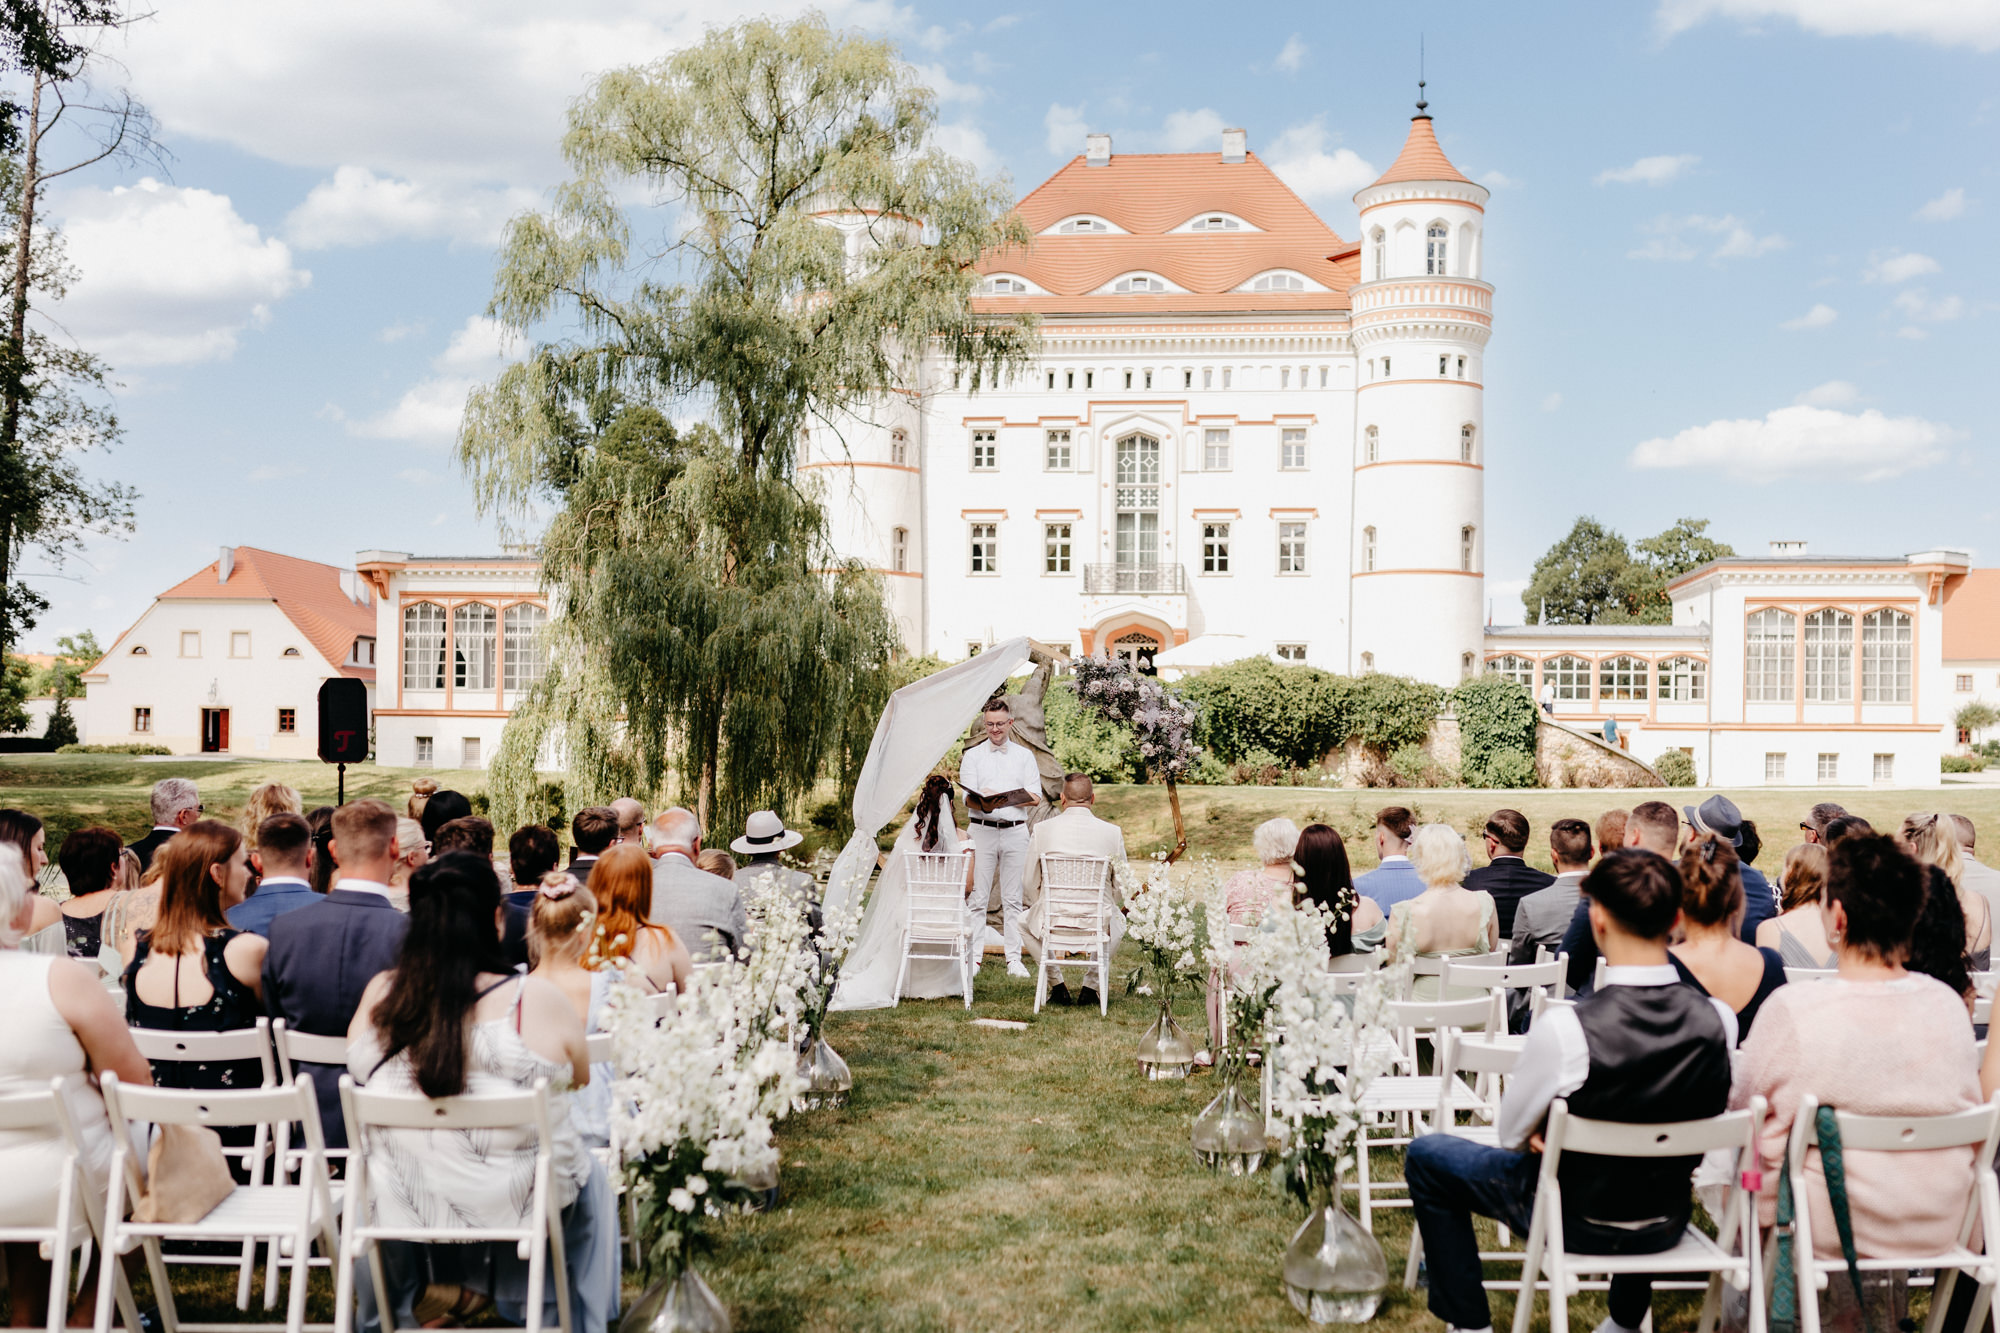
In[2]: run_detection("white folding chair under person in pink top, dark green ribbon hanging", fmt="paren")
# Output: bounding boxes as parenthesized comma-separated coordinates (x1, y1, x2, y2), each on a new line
(1784, 1097, 2000, 1333)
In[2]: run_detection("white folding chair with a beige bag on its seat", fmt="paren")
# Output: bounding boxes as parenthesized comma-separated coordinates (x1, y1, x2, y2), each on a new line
(96, 1073, 344, 1333)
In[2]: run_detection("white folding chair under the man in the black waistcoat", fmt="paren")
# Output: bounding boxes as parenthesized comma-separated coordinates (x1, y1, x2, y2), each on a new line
(1514, 1097, 1764, 1333)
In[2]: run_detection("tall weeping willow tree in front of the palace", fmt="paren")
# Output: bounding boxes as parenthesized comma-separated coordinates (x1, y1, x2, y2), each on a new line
(458, 16, 1034, 827)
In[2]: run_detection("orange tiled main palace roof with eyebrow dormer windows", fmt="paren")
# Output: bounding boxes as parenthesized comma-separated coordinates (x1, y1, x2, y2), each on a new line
(976, 152, 1360, 314)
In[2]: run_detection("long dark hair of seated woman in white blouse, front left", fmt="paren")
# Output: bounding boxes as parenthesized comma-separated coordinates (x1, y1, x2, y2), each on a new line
(370, 853, 508, 1097)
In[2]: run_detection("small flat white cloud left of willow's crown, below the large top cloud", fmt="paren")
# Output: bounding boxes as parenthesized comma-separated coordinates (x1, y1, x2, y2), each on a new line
(284, 166, 540, 250)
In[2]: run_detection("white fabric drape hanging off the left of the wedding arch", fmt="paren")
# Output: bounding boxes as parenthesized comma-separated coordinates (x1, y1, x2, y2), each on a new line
(826, 638, 1028, 911)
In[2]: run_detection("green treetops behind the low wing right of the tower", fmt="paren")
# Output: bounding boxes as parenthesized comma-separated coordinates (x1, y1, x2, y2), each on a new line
(1520, 516, 1736, 624)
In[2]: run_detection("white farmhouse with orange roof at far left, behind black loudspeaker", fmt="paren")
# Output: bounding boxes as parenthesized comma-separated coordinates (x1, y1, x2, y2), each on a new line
(84, 546, 376, 759)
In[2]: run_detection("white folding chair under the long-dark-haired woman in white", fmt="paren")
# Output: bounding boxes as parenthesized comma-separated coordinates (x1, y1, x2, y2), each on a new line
(334, 1075, 572, 1333)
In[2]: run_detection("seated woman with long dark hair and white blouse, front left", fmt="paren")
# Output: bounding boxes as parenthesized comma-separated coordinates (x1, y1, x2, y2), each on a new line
(350, 852, 618, 1333)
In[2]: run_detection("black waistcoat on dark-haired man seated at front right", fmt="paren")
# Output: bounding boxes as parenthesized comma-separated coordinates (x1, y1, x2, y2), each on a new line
(1558, 985, 1730, 1255)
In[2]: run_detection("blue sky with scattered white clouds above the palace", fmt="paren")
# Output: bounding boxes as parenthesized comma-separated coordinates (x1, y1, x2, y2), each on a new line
(7, 0, 2000, 648)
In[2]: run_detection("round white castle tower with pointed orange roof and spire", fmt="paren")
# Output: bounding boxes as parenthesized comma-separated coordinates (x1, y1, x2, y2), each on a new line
(1348, 100, 1492, 685)
